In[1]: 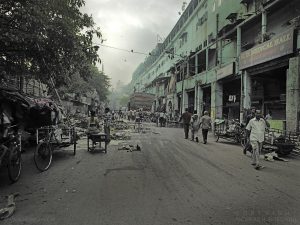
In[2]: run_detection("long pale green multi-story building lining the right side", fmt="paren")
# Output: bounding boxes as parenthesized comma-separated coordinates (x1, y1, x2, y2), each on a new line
(131, 0, 300, 130)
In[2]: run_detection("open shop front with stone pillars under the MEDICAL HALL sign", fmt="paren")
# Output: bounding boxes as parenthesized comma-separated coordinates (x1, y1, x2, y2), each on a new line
(240, 30, 299, 131)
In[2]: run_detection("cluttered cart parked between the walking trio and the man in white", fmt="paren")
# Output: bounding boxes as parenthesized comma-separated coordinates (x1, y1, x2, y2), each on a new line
(214, 119, 246, 146)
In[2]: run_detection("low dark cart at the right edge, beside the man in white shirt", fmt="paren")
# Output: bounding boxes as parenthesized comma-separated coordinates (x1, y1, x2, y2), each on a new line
(263, 128, 300, 156)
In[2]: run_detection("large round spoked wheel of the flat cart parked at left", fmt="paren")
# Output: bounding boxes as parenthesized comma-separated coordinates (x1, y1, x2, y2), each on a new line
(34, 142, 52, 172)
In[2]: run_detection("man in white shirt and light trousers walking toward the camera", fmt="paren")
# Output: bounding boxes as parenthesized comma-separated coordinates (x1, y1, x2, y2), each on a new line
(246, 110, 270, 170)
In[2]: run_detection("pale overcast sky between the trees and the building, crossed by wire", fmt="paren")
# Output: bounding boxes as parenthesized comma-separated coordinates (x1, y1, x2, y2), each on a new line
(83, 0, 189, 86)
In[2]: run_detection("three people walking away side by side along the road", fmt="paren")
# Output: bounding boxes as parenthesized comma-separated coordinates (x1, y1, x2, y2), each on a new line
(179, 108, 212, 144)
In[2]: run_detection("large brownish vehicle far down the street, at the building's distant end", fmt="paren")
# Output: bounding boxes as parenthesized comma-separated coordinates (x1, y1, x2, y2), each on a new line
(128, 92, 155, 111)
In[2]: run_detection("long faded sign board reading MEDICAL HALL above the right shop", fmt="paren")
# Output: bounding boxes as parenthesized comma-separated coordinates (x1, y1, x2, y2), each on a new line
(240, 30, 294, 70)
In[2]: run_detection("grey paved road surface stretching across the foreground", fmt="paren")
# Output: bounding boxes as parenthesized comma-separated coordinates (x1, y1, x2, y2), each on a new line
(0, 125, 300, 225)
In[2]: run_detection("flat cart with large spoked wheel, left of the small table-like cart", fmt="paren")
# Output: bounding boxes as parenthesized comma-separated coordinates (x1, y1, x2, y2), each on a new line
(34, 126, 77, 172)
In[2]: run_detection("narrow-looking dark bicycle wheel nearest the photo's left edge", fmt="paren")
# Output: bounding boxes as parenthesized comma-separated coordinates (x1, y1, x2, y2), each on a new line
(7, 146, 22, 182)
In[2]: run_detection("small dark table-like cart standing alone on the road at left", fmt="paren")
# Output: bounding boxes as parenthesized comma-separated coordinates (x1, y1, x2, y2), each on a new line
(87, 133, 109, 153)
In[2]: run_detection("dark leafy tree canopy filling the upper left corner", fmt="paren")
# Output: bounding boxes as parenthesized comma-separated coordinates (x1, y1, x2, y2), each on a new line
(0, 0, 101, 87)
